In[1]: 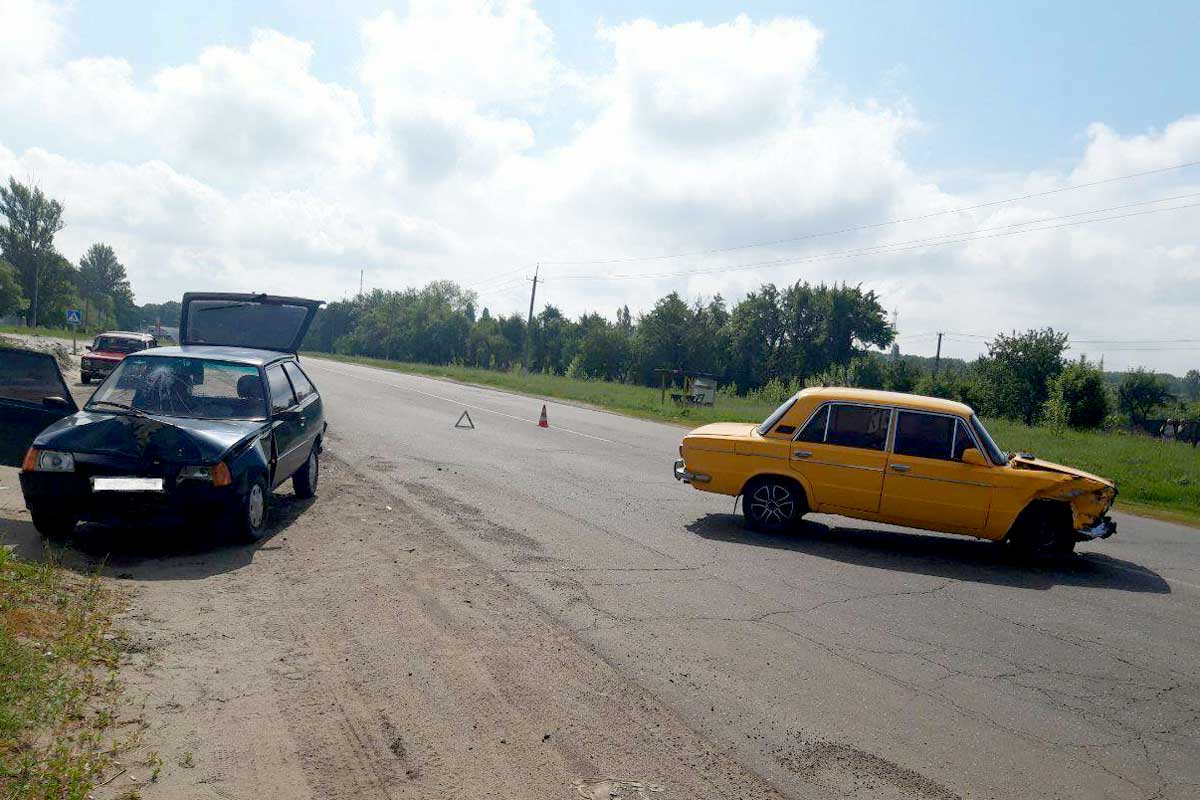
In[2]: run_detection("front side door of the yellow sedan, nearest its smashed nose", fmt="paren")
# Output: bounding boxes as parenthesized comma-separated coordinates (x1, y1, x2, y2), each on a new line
(880, 409, 994, 531)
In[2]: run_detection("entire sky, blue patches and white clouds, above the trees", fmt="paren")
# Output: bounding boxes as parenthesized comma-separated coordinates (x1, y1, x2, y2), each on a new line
(0, 0, 1200, 372)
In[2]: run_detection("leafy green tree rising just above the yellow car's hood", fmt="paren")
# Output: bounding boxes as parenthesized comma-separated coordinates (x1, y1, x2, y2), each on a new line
(979, 327, 1070, 425)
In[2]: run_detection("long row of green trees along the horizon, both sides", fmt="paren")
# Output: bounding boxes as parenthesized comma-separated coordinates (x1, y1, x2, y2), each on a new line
(0, 179, 1200, 428)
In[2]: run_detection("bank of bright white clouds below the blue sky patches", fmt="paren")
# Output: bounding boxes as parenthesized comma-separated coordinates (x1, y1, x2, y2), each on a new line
(0, 0, 1200, 371)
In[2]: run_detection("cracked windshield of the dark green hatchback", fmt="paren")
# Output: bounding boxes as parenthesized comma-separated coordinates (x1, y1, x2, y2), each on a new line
(86, 355, 266, 420)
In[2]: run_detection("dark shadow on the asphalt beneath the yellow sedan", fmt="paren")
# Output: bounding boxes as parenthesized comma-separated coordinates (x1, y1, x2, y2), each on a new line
(688, 513, 1171, 595)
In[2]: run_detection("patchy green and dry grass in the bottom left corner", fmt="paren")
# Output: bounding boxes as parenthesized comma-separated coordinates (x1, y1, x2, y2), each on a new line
(0, 547, 130, 800)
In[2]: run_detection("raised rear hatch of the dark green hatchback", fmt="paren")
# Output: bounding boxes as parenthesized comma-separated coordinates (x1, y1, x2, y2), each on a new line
(179, 291, 324, 353)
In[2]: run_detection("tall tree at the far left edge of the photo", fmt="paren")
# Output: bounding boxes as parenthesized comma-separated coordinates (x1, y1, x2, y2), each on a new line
(0, 178, 62, 325)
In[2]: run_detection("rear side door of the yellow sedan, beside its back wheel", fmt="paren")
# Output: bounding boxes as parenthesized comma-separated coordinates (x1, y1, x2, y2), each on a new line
(788, 403, 892, 513)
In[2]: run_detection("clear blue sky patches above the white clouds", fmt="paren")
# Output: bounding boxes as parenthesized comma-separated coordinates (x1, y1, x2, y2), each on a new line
(60, 0, 1200, 179)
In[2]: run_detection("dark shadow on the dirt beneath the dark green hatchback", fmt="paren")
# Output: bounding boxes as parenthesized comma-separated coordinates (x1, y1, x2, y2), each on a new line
(0, 494, 314, 581)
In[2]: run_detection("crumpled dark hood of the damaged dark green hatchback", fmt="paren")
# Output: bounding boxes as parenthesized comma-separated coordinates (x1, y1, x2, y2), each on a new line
(34, 411, 268, 464)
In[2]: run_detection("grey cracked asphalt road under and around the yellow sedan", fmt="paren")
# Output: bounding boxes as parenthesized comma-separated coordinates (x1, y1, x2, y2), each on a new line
(305, 359, 1200, 799)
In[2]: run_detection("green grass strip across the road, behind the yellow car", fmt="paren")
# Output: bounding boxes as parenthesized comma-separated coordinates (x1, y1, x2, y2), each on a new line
(312, 353, 1200, 524)
